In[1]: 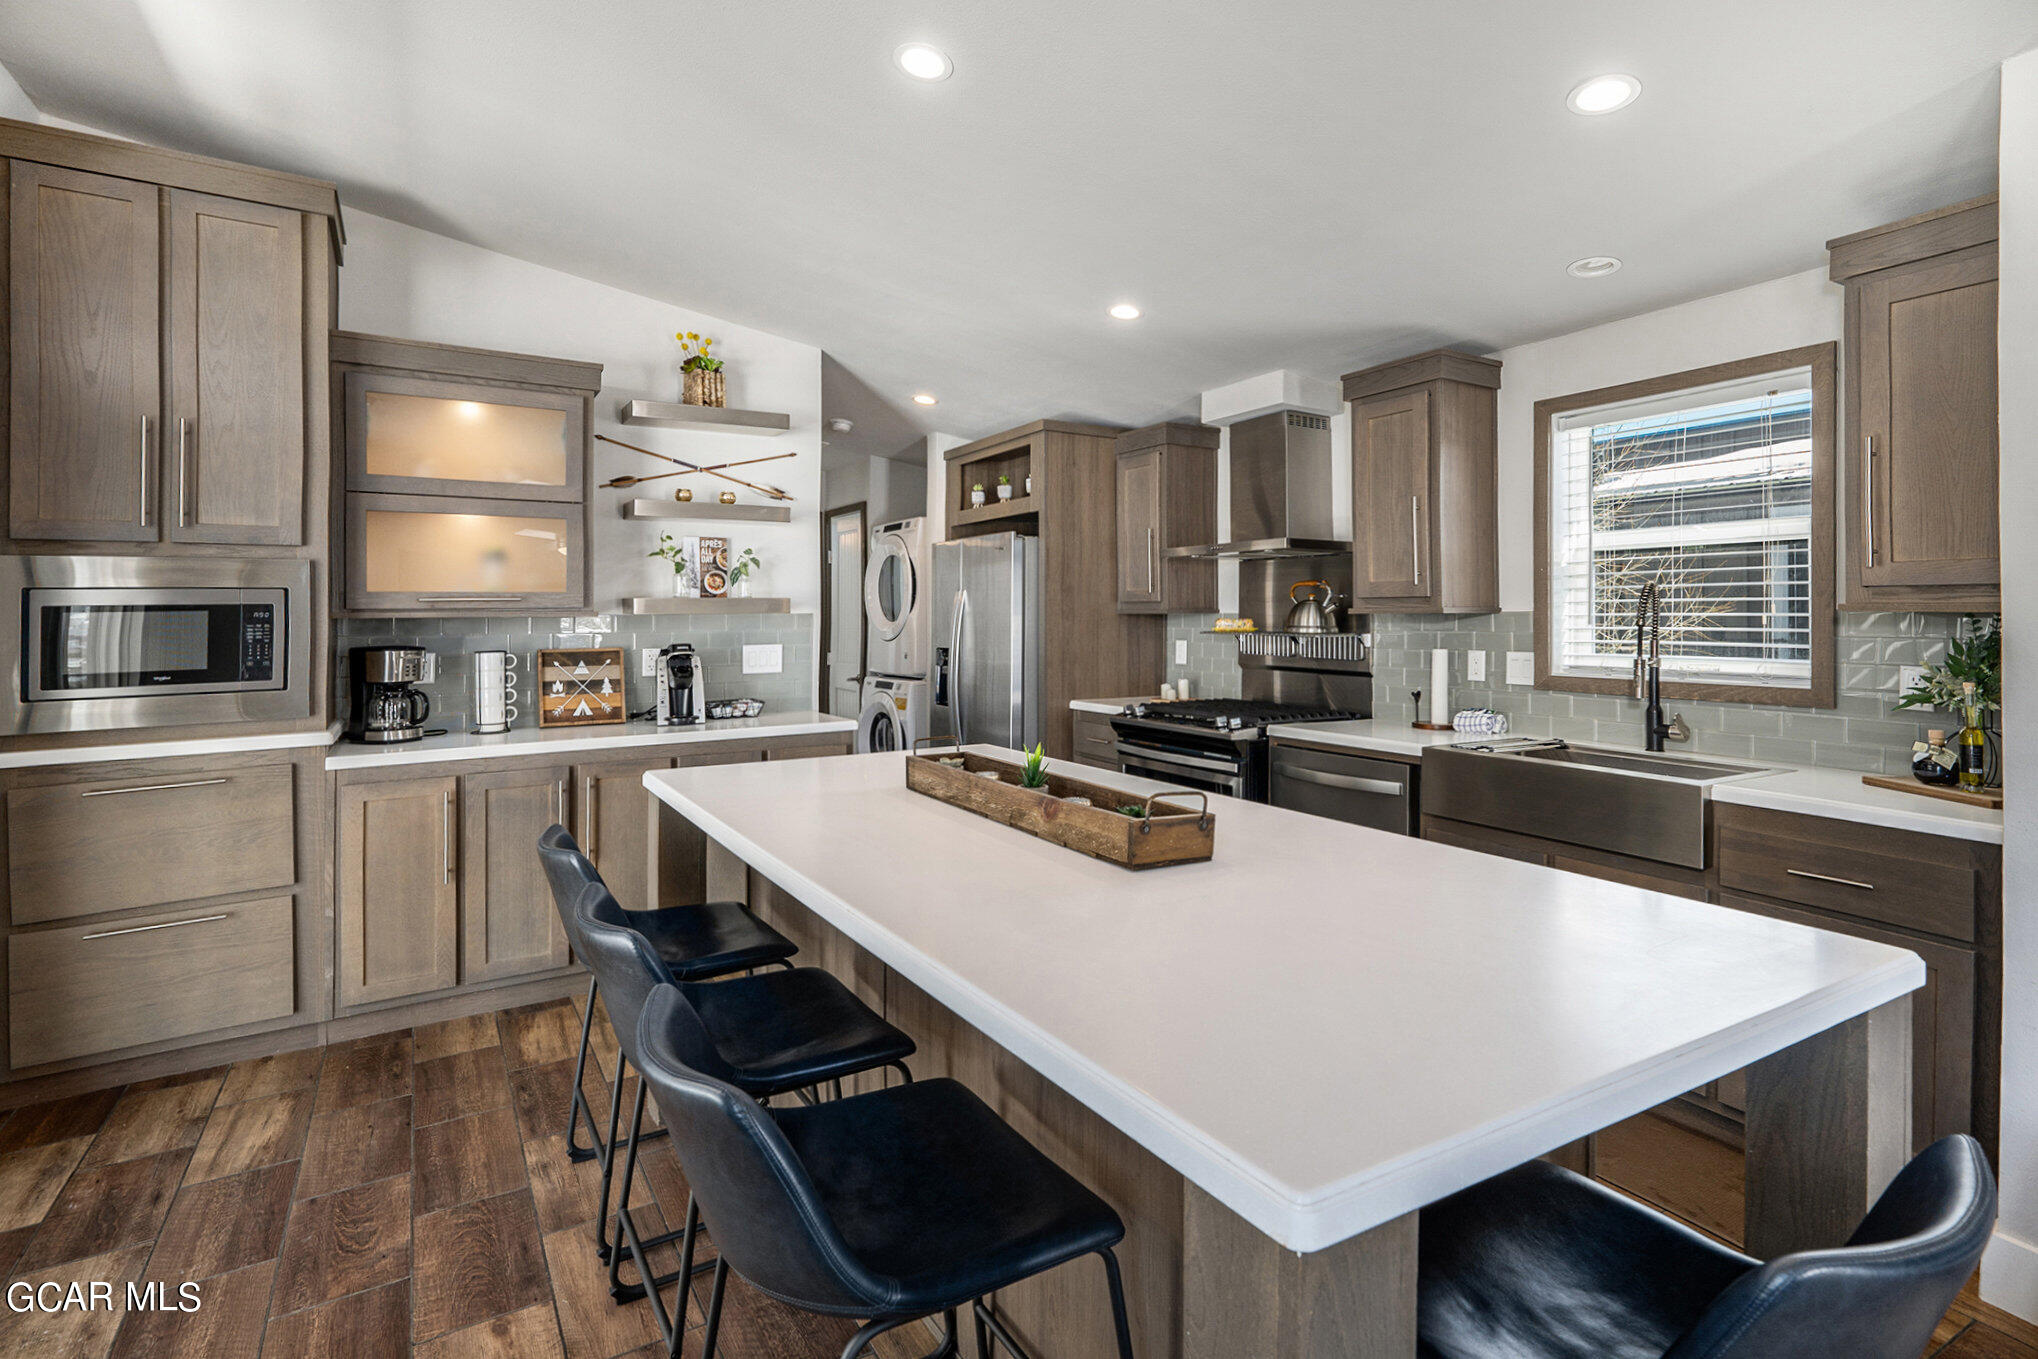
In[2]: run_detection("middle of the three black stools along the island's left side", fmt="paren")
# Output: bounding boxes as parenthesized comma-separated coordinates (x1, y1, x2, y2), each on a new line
(575, 882, 915, 1328)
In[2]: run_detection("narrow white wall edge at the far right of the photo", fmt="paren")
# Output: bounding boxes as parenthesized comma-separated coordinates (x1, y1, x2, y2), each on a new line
(1981, 51, 2038, 1320)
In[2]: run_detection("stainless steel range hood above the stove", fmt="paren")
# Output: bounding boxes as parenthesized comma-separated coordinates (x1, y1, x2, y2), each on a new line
(1166, 410, 1351, 560)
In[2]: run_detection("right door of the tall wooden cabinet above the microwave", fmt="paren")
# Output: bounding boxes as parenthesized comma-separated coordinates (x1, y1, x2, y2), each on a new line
(163, 189, 306, 544)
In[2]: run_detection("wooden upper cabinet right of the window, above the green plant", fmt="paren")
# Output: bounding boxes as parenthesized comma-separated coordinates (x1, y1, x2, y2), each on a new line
(1826, 196, 2001, 611)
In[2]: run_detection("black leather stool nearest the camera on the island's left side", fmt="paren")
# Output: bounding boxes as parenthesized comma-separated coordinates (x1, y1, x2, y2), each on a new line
(622, 986, 1133, 1359)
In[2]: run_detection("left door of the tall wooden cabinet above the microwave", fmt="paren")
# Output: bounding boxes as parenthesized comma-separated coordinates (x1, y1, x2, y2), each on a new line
(6, 161, 163, 542)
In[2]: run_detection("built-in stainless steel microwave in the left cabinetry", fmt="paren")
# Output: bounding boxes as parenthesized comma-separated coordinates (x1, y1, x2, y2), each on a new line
(0, 556, 312, 736)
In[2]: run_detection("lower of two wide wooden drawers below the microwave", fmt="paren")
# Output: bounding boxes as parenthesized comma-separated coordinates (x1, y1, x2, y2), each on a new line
(8, 896, 298, 1070)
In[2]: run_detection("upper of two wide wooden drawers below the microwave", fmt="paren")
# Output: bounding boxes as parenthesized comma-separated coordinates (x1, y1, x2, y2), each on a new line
(6, 764, 298, 925)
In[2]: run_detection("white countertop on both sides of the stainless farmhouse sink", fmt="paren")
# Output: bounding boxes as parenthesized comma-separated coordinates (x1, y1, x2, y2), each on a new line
(1268, 721, 2003, 846)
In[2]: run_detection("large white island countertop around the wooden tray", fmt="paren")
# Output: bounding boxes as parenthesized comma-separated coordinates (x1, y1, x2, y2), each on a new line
(644, 754, 1924, 1251)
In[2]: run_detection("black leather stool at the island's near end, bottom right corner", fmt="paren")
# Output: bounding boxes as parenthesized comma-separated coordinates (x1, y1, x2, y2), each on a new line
(1418, 1140, 1995, 1359)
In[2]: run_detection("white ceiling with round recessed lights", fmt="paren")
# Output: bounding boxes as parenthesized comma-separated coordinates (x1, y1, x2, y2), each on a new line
(0, 0, 2038, 454)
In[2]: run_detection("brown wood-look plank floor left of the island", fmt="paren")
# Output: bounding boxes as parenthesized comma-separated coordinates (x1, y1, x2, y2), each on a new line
(0, 1000, 925, 1359)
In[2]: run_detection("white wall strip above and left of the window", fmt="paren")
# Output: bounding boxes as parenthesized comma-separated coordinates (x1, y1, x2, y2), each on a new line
(1494, 269, 1844, 609)
